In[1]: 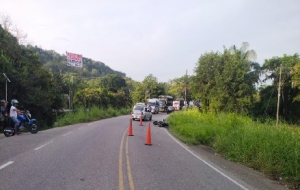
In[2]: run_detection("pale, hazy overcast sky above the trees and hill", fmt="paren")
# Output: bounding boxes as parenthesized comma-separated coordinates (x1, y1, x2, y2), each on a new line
(0, 0, 300, 82)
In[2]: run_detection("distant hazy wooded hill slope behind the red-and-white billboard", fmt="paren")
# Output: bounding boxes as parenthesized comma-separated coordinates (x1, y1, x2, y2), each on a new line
(30, 46, 126, 77)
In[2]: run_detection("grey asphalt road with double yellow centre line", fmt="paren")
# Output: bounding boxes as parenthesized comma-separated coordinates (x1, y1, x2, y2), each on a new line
(0, 113, 285, 190)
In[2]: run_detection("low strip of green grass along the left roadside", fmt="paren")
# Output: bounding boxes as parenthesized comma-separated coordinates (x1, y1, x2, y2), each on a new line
(55, 107, 131, 127)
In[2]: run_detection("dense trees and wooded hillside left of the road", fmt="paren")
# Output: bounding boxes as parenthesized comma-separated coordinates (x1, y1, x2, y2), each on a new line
(0, 23, 132, 129)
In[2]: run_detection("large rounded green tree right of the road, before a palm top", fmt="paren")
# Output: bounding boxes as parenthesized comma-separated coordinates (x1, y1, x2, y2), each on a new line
(191, 43, 261, 113)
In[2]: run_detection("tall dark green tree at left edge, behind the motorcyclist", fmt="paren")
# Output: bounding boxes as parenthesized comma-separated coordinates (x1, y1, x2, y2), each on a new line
(0, 26, 66, 126)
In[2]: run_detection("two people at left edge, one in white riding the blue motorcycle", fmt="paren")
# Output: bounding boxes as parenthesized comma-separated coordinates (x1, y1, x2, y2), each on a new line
(0, 99, 23, 133)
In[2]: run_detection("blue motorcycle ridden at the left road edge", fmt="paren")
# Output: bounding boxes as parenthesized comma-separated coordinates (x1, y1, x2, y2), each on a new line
(3, 110, 39, 137)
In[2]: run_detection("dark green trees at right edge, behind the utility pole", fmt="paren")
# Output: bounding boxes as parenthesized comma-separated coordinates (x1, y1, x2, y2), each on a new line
(255, 54, 300, 122)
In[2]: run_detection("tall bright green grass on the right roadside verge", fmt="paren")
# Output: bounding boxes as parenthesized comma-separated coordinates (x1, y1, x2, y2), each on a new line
(167, 110, 300, 187)
